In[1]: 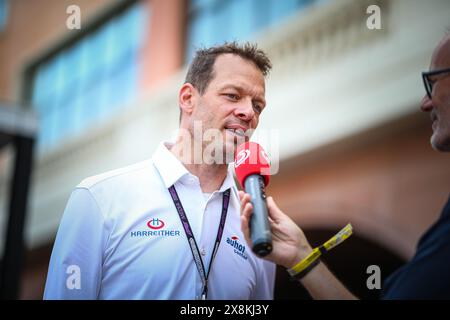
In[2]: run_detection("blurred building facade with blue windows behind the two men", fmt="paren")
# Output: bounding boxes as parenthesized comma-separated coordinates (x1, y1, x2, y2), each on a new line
(0, 0, 450, 299)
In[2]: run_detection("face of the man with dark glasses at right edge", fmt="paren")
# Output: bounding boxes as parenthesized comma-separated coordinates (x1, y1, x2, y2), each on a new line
(421, 36, 450, 151)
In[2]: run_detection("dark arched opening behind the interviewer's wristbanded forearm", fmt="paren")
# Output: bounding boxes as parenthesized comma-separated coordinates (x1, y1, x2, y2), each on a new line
(275, 229, 406, 300)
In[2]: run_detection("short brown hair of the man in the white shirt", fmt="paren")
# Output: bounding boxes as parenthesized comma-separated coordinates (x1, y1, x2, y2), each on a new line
(184, 41, 272, 94)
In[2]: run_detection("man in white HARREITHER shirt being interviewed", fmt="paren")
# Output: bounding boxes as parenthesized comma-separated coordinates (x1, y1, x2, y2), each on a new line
(44, 43, 275, 299)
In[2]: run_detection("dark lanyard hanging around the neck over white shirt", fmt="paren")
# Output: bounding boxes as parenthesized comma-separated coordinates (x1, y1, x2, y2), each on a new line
(169, 185, 230, 300)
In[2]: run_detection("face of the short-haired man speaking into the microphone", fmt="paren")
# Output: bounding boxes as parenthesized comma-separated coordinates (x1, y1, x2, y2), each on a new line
(191, 54, 266, 161)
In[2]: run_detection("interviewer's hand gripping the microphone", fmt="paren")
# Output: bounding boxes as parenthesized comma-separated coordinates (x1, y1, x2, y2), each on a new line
(239, 191, 312, 268)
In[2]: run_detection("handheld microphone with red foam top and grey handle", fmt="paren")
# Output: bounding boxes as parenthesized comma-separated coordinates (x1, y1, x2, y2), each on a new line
(234, 142, 272, 257)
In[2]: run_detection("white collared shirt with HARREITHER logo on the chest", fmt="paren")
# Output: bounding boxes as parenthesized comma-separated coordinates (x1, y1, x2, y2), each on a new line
(44, 143, 275, 299)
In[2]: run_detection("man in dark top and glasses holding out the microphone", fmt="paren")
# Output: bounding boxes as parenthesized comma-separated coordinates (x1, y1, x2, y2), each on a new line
(239, 35, 450, 299)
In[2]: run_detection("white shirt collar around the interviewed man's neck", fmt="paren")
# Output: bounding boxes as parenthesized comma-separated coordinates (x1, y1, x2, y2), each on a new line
(152, 142, 237, 192)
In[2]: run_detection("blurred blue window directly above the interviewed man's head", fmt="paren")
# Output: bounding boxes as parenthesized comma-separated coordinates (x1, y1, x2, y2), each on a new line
(186, 0, 313, 61)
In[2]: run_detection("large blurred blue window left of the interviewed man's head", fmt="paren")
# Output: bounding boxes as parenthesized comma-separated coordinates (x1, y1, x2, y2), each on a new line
(31, 2, 148, 150)
